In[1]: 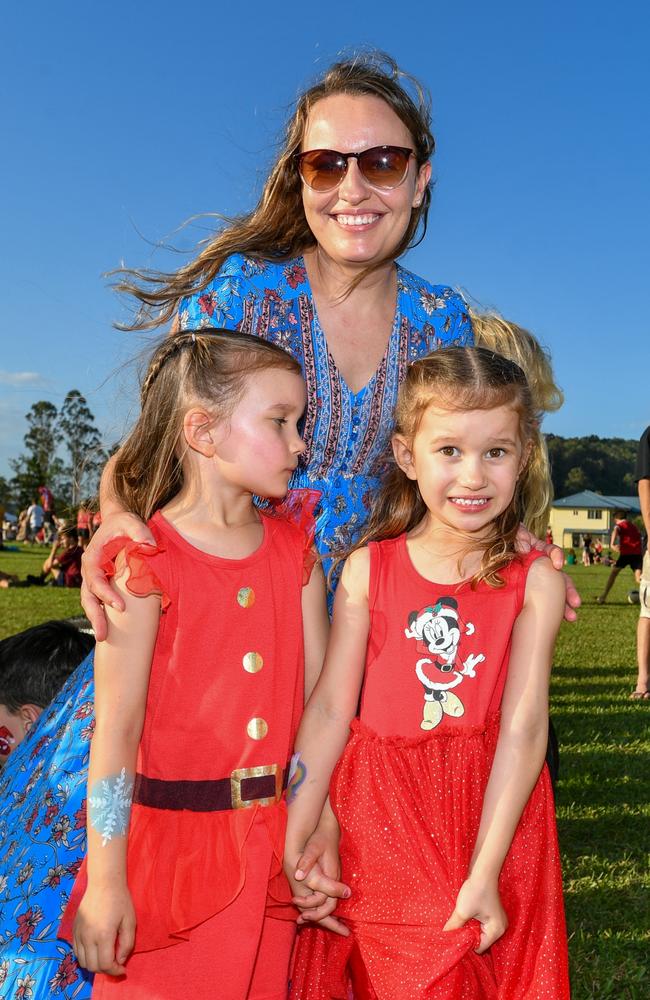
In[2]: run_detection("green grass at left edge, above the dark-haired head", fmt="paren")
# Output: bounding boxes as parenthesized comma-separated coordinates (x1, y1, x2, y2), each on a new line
(0, 542, 83, 639)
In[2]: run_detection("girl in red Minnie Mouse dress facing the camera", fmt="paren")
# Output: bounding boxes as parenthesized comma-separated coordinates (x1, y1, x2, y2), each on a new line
(285, 348, 569, 1000)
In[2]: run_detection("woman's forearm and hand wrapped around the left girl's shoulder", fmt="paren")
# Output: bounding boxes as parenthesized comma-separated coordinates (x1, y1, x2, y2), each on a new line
(80, 455, 154, 642)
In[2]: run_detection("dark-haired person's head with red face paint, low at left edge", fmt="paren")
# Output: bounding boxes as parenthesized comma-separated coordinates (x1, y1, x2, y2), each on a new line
(0, 621, 95, 762)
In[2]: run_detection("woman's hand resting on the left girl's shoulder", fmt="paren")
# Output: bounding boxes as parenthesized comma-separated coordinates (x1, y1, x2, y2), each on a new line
(81, 511, 155, 642)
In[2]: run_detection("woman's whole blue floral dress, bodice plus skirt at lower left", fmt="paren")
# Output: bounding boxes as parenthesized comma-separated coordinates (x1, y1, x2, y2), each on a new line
(0, 255, 473, 1000)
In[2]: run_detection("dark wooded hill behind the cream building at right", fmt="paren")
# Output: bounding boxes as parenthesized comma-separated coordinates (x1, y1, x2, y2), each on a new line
(546, 434, 639, 498)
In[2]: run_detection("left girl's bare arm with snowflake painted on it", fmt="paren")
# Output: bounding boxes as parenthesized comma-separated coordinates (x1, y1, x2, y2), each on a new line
(73, 560, 160, 976)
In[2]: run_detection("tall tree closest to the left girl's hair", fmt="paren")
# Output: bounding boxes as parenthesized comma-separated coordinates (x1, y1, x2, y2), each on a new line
(58, 389, 106, 508)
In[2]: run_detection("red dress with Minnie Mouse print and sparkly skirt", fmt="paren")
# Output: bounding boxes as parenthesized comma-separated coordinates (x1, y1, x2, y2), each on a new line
(291, 535, 569, 1000)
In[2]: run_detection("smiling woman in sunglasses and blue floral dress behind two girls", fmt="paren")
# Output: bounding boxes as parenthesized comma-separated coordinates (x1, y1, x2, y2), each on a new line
(84, 54, 473, 635)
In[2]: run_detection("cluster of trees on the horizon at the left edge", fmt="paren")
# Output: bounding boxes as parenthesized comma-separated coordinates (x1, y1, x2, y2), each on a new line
(0, 389, 109, 514)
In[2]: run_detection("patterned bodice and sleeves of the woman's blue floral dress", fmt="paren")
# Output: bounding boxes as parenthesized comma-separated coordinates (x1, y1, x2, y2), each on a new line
(179, 254, 473, 584)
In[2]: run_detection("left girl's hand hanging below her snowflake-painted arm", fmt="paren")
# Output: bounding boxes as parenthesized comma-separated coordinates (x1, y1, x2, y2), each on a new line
(72, 886, 136, 976)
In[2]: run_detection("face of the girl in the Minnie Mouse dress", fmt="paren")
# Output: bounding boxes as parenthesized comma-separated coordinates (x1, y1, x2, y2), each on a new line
(394, 406, 526, 532)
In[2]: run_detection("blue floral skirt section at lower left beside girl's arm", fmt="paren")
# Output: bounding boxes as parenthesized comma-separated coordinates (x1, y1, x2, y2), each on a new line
(0, 654, 93, 1000)
